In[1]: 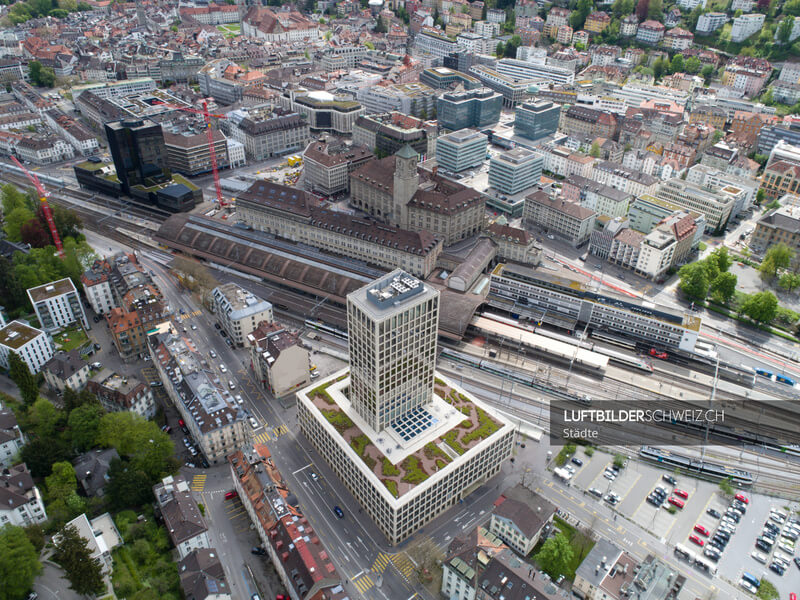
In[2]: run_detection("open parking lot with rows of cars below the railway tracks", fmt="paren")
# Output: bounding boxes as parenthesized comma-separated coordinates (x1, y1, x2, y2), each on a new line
(552, 447, 800, 598)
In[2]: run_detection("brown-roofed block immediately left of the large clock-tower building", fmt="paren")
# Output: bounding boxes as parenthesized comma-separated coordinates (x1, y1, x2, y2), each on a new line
(303, 139, 375, 196)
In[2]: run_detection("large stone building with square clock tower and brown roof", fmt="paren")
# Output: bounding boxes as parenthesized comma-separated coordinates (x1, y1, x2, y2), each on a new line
(350, 146, 485, 246)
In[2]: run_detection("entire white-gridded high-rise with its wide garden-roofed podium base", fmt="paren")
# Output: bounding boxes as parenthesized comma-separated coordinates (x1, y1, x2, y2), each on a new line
(297, 269, 514, 545)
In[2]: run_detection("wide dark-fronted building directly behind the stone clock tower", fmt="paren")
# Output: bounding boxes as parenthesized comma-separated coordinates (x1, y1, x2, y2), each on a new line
(353, 112, 438, 157)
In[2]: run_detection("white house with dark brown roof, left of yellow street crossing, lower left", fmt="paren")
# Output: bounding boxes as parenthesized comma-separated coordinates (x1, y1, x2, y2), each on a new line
(153, 475, 211, 559)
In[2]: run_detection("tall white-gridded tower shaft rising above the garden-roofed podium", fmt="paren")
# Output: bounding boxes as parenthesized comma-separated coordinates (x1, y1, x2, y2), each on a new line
(347, 269, 439, 431)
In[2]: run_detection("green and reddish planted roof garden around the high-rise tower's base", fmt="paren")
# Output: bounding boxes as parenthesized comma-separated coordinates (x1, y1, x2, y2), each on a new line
(308, 375, 500, 498)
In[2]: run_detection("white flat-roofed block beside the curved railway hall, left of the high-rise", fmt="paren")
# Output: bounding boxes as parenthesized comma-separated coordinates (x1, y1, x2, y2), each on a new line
(211, 283, 273, 346)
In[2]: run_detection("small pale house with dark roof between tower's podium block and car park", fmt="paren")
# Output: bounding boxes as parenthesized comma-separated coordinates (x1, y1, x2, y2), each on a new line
(489, 484, 556, 557)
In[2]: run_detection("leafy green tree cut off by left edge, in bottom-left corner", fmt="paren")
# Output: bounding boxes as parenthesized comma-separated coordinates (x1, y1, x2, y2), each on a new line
(0, 525, 42, 600)
